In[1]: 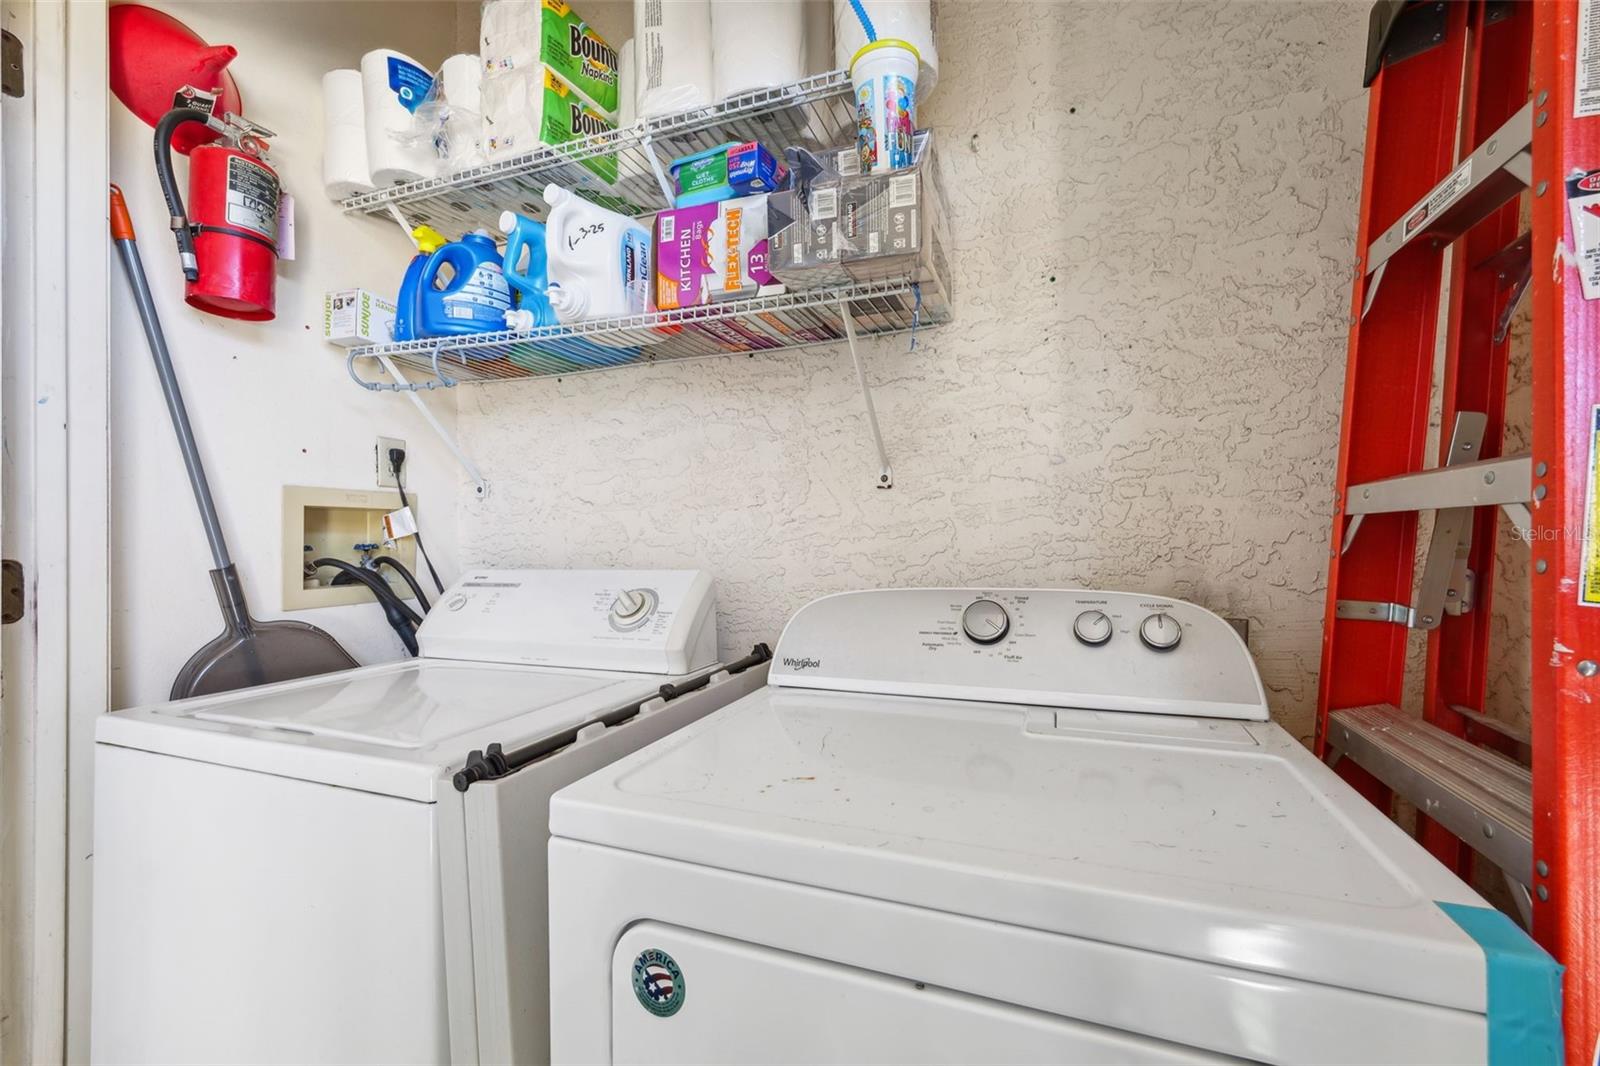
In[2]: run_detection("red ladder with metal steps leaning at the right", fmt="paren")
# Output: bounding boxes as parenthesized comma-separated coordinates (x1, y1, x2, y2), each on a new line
(1317, 0, 1600, 1063)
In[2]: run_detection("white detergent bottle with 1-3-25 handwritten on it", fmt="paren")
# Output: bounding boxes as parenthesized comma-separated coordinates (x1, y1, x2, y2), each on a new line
(544, 186, 650, 328)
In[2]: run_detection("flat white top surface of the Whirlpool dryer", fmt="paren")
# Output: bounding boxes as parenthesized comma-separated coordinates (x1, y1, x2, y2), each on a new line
(550, 685, 1486, 1012)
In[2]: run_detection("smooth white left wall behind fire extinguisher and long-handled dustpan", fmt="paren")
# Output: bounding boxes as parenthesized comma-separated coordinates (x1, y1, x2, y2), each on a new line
(107, 0, 459, 707)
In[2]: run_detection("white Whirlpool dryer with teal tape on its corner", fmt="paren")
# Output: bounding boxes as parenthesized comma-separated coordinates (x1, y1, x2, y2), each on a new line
(550, 589, 1560, 1066)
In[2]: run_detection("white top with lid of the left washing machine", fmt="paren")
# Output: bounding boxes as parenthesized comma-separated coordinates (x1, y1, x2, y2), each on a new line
(94, 659, 685, 800)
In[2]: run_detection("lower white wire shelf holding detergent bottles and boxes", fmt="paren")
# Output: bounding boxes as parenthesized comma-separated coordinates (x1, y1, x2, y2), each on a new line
(347, 275, 950, 391)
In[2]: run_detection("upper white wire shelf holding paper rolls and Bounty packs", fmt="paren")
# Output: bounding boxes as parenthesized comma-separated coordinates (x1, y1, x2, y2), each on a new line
(341, 70, 856, 235)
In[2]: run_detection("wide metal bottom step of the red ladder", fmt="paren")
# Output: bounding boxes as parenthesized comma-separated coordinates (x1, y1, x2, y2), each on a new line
(1328, 704, 1533, 885)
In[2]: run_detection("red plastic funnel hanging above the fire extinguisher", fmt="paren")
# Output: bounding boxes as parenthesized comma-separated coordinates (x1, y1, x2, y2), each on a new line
(110, 3, 245, 155)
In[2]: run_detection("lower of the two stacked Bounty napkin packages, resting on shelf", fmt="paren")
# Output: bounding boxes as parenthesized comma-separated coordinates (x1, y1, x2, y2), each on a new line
(482, 66, 616, 182)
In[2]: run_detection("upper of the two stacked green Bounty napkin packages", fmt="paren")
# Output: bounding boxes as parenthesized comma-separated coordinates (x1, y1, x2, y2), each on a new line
(478, 0, 618, 122)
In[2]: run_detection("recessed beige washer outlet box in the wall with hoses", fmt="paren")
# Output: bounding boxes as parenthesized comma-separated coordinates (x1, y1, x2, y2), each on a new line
(283, 485, 418, 611)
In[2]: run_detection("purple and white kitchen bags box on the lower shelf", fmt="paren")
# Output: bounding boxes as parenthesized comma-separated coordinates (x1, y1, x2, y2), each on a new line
(654, 195, 784, 311)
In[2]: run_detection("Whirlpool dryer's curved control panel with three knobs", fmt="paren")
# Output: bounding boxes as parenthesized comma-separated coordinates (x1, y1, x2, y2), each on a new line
(770, 589, 1267, 722)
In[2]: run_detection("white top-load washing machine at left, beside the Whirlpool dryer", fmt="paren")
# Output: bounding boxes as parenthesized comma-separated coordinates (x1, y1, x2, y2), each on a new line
(91, 570, 768, 1063)
